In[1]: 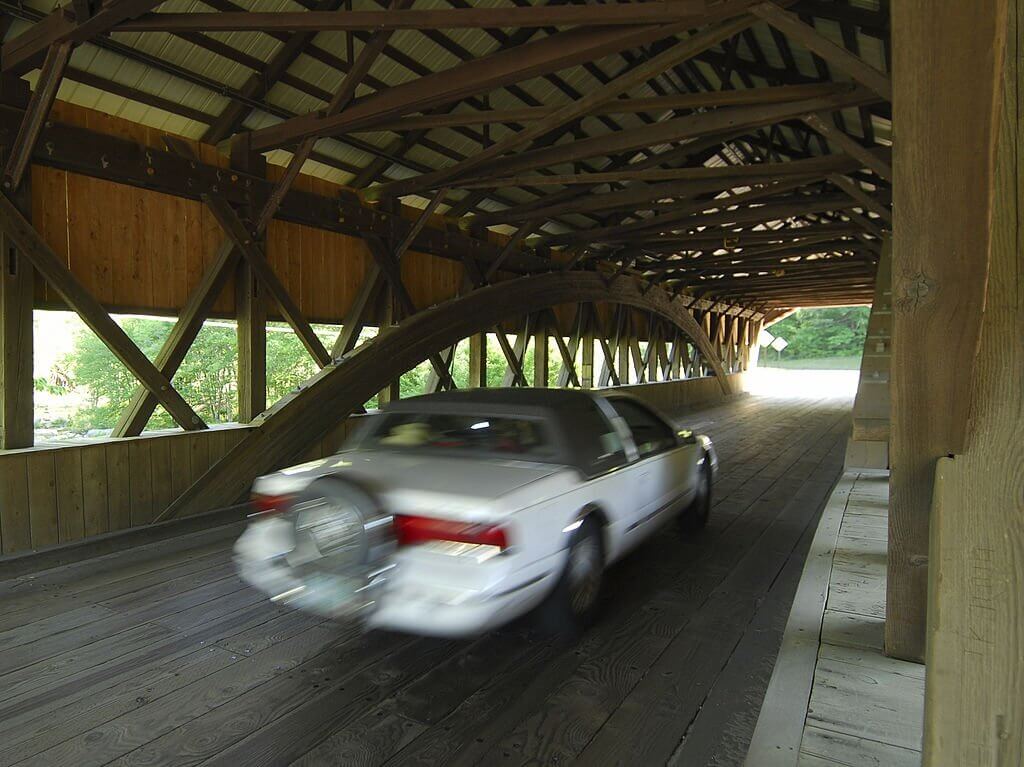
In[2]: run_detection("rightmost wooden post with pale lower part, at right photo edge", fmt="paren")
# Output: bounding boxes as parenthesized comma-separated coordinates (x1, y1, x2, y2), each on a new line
(924, 0, 1024, 767)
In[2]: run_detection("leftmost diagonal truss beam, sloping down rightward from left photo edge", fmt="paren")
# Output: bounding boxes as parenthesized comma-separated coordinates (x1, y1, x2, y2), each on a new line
(0, 195, 206, 430)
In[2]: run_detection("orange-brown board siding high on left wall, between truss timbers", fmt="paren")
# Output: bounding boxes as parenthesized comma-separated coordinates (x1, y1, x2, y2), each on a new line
(24, 102, 462, 323)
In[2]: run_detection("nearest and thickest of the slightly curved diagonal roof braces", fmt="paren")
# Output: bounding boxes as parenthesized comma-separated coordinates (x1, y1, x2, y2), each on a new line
(252, 25, 716, 152)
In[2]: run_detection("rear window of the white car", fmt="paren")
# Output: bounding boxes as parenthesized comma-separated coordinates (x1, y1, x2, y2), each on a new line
(359, 413, 556, 461)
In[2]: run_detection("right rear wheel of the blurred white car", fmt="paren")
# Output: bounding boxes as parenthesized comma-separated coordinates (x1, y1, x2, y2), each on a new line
(539, 517, 604, 638)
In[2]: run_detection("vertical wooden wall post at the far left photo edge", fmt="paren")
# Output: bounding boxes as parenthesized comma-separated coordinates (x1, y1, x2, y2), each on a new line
(0, 140, 35, 450)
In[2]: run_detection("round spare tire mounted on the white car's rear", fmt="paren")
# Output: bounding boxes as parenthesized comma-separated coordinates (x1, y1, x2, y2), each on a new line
(288, 477, 396, 619)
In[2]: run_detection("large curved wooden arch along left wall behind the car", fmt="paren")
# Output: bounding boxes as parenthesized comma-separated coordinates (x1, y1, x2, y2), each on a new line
(156, 271, 729, 521)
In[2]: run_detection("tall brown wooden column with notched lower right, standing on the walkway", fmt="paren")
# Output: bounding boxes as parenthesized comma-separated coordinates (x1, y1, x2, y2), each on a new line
(886, 0, 1007, 661)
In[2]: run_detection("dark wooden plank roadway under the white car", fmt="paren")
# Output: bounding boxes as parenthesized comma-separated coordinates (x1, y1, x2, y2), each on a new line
(0, 397, 850, 767)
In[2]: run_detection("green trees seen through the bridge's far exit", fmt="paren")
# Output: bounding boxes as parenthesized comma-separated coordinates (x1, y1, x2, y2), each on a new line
(762, 306, 869, 363)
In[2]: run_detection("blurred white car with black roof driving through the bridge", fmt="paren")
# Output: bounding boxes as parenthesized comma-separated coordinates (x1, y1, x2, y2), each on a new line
(234, 388, 717, 637)
